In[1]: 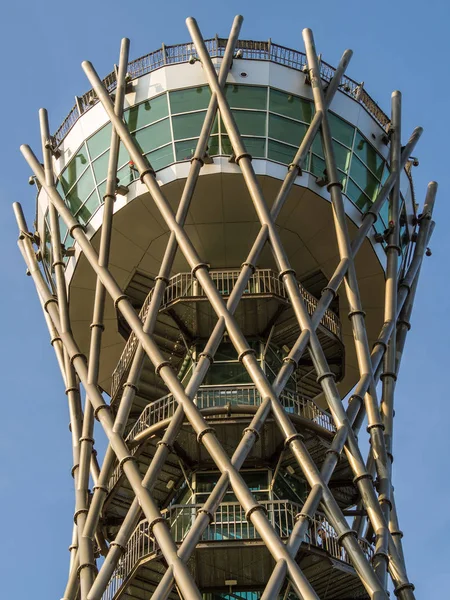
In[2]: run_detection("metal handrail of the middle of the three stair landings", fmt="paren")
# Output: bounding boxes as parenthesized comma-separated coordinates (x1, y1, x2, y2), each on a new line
(127, 385, 336, 442)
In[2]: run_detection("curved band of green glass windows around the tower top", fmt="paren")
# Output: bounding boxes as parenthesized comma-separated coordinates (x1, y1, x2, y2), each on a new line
(44, 84, 408, 262)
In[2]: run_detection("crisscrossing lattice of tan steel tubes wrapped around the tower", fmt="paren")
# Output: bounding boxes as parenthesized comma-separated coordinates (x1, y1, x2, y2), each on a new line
(14, 12, 437, 600)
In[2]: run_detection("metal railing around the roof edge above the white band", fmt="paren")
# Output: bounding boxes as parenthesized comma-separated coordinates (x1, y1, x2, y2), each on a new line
(53, 37, 390, 144)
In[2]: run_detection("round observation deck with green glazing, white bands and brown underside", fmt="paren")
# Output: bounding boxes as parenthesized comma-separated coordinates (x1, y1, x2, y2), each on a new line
(37, 38, 415, 404)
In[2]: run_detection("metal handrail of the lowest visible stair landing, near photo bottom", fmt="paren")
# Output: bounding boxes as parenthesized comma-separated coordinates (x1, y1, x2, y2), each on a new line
(102, 500, 374, 600)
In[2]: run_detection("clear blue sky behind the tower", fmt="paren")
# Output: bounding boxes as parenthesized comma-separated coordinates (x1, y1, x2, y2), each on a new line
(0, 0, 450, 600)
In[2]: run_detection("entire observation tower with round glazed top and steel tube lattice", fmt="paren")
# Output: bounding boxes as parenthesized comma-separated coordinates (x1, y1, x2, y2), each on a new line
(14, 16, 437, 600)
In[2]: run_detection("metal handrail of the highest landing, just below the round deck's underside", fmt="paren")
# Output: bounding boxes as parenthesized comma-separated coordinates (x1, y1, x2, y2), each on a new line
(111, 269, 342, 399)
